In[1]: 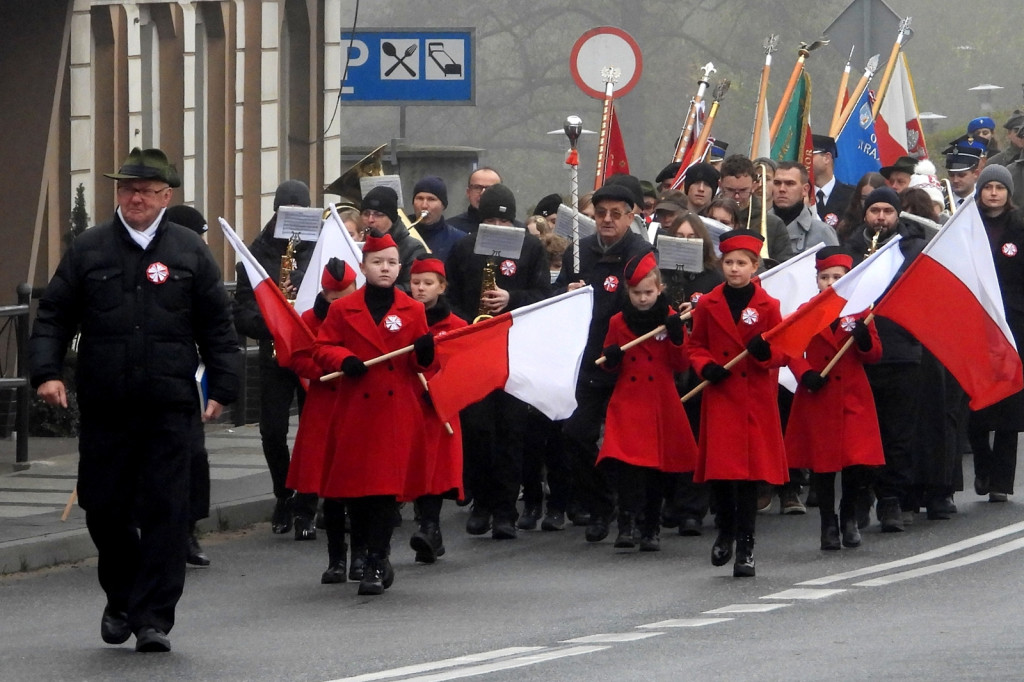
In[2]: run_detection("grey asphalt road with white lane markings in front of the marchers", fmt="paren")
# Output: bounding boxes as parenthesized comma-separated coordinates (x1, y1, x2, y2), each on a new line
(0, 481, 1024, 682)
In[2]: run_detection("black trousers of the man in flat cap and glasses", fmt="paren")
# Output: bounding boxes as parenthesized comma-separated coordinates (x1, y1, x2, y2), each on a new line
(562, 380, 615, 518)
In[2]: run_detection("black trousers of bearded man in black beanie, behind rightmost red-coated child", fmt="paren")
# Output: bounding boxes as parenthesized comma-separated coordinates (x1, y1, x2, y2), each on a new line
(864, 364, 921, 506)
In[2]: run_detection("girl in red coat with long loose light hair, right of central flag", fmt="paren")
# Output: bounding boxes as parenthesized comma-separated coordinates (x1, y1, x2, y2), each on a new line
(597, 253, 697, 552)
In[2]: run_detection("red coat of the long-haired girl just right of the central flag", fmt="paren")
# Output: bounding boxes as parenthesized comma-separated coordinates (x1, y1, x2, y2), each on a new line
(597, 312, 697, 472)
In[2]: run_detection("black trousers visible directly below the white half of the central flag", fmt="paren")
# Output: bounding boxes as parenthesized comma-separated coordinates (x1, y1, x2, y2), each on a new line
(522, 408, 572, 511)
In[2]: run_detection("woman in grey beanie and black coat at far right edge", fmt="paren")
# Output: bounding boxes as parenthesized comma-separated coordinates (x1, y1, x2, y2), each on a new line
(968, 165, 1024, 502)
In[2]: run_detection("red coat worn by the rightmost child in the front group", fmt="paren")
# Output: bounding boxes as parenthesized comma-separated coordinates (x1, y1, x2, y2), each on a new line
(785, 317, 886, 473)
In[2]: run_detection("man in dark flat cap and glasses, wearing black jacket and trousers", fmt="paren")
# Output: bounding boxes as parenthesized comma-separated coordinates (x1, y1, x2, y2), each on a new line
(555, 184, 652, 542)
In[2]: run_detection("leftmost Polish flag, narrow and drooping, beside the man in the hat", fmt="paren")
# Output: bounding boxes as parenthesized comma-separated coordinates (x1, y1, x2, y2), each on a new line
(220, 218, 311, 368)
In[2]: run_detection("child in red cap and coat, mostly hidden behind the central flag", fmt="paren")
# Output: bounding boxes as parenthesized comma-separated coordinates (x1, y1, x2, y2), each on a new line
(408, 256, 466, 563)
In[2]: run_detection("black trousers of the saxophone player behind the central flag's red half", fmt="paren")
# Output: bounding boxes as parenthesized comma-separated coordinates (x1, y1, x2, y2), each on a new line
(461, 391, 526, 522)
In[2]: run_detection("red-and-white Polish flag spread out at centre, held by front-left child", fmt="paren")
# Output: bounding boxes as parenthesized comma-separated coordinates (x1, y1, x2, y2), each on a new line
(429, 287, 594, 420)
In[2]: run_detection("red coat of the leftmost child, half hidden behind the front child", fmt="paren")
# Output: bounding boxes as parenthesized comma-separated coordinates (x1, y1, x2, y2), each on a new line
(286, 308, 338, 494)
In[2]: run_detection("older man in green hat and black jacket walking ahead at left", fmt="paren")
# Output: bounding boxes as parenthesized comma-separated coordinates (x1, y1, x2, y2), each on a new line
(30, 148, 239, 651)
